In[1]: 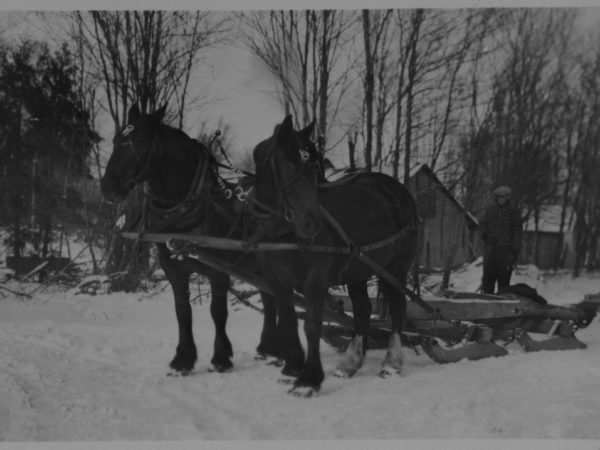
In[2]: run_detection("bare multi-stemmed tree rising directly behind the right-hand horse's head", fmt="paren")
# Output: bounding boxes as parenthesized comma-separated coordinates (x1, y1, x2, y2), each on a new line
(240, 10, 354, 147)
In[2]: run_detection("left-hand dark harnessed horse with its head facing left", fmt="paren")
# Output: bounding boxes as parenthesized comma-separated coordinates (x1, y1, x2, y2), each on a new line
(101, 106, 304, 375)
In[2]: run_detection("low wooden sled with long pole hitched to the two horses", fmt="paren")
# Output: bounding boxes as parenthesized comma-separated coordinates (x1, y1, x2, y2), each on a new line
(123, 233, 597, 363)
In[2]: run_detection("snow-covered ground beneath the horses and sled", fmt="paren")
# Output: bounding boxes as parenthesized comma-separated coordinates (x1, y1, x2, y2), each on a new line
(0, 265, 600, 442)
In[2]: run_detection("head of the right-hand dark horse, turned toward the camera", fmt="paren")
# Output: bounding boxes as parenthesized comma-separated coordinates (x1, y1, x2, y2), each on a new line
(253, 116, 323, 238)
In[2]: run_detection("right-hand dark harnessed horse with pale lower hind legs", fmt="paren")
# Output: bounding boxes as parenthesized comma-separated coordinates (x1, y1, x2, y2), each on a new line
(253, 116, 418, 396)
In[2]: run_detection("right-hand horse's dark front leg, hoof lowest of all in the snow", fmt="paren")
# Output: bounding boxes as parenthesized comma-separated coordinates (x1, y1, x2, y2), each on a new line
(290, 269, 327, 397)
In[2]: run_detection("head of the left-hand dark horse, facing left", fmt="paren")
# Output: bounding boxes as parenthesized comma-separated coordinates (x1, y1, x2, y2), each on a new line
(100, 105, 166, 201)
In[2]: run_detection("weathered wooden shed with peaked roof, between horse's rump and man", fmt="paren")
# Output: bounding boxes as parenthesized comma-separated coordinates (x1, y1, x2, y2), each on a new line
(408, 164, 479, 270)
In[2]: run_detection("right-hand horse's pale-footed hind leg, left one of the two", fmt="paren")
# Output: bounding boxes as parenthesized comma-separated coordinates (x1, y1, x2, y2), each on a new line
(334, 281, 371, 378)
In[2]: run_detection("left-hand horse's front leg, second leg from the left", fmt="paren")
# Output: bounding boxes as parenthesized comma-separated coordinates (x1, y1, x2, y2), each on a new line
(209, 272, 233, 372)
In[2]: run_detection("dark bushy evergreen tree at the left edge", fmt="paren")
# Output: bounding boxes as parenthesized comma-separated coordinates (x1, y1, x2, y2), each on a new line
(0, 42, 99, 257)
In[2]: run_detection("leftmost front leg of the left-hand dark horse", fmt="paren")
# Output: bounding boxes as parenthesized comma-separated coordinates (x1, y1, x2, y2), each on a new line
(159, 245, 197, 375)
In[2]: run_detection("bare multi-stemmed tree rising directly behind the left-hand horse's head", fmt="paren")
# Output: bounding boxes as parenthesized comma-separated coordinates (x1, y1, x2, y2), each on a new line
(71, 11, 228, 289)
